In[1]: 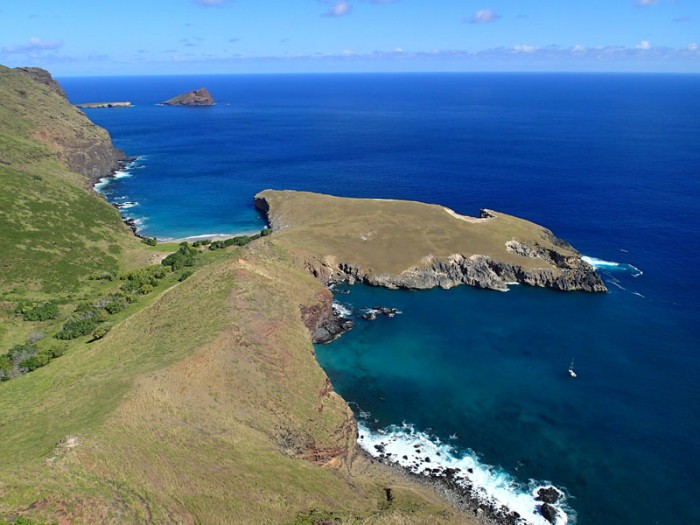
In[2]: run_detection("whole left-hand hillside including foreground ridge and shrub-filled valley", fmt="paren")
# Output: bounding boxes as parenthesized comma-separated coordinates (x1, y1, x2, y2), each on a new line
(0, 68, 471, 525)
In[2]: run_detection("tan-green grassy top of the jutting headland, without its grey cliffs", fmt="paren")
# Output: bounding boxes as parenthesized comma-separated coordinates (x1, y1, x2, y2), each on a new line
(261, 190, 576, 274)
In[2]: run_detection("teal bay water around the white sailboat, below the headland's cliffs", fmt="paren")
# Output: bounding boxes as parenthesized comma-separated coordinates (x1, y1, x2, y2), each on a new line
(316, 274, 700, 523)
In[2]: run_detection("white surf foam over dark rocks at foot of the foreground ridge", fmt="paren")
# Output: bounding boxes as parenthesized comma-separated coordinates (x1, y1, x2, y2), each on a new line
(358, 421, 573, 525)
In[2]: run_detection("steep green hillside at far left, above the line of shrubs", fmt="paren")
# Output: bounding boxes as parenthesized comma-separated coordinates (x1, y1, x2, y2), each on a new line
(0, 66, 148, 300)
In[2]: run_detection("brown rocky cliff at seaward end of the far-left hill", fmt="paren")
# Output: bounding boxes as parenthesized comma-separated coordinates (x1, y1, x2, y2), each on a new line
(8, 67, 125, 181)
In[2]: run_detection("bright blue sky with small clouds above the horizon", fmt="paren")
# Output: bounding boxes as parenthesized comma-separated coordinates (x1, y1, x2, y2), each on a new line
(0, 0, 700, 76)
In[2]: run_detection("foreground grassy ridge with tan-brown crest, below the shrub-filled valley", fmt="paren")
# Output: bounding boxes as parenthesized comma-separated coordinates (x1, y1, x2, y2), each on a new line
(0, 240, 476, 524)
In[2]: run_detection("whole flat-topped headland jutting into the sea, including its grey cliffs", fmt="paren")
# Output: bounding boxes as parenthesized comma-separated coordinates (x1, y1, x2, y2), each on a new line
(256, 190, 607, 292)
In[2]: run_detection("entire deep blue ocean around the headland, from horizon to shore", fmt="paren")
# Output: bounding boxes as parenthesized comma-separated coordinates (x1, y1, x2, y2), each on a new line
(60, 74, 700, 525)
